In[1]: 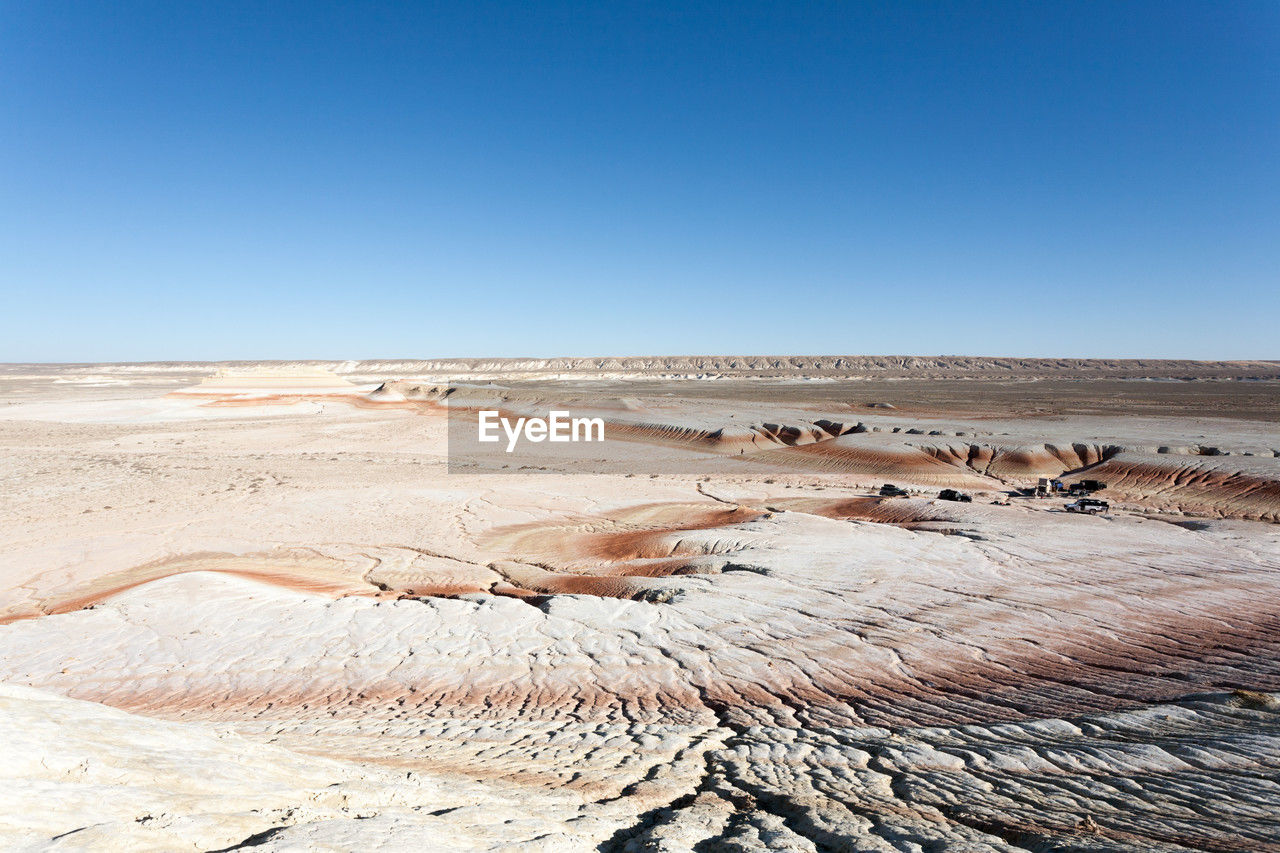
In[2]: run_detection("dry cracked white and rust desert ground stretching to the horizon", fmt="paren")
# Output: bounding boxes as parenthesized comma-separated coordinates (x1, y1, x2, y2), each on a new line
(0, 360, 1280, 852)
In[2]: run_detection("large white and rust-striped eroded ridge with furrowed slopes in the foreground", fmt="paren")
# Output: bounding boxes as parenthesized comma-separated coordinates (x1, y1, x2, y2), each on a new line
(5, 501, 1280, 849)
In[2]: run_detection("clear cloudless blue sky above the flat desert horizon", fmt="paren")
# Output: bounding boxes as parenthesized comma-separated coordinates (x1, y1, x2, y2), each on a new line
(0, 0, 1280, 361)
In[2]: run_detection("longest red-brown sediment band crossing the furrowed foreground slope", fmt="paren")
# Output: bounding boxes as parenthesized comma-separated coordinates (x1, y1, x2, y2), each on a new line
(62, 581, 1280, 726)
